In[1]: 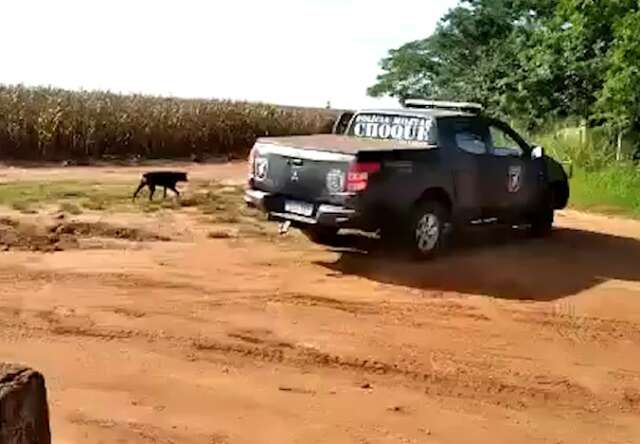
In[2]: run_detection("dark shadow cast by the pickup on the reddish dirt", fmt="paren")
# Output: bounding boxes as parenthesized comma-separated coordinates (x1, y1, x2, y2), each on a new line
(317, 228, 640, 301)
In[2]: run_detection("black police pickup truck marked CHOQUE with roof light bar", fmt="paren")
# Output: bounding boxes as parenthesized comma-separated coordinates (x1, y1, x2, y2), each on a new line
(245, 101, 569, 258)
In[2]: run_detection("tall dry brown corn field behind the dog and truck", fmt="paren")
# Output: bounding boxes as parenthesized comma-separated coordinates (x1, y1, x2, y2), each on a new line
(0, 86, 336, 160)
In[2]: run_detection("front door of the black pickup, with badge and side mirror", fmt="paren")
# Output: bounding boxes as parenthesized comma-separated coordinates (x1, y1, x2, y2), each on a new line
(488, 120, 545, 217)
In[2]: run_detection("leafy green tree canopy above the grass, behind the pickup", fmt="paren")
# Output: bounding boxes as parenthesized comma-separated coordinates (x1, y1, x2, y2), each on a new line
(369, 0, 640, 131)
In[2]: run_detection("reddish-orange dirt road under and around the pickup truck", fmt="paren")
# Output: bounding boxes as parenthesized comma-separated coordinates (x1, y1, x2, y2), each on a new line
(0, 165, 640, 444)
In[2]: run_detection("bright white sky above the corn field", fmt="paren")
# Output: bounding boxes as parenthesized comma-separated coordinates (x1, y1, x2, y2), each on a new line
(0, 0, 456, 108)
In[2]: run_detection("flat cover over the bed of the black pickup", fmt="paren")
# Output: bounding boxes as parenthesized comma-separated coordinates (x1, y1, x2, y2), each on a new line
(257, 134, 433, 154)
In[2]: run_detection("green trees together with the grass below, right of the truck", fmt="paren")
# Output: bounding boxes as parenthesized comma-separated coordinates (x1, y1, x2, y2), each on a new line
(369, 0, 640, 215)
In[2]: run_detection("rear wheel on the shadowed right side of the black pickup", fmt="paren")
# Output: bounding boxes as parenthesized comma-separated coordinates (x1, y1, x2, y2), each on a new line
(406, 201, 449, 260)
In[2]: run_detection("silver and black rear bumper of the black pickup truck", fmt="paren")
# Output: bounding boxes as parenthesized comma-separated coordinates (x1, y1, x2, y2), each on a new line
(244, 189, 361, 228)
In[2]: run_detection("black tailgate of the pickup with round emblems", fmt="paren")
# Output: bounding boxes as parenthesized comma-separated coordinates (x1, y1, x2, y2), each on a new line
(253, 142, 355, 203)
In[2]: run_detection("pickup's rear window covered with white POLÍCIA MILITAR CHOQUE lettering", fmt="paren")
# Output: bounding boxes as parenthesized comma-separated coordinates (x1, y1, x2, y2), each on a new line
(348, 113, 436, 145)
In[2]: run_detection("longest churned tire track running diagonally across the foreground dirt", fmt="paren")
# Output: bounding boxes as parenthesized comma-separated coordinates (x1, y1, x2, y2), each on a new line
(0, 306, 616, 411)
